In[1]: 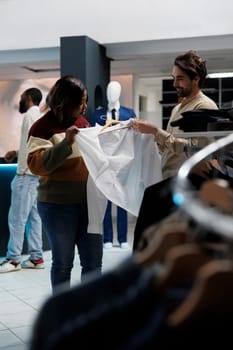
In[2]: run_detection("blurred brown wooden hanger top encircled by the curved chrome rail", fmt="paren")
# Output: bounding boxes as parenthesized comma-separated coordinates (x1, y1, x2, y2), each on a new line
(198, 179, 233, 214)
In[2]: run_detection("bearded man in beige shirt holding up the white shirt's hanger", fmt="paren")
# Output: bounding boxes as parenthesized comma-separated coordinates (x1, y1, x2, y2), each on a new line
(133, 50, 218, 250)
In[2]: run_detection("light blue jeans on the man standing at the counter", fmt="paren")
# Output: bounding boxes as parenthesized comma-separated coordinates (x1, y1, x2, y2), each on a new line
(6, 175, 43, 261)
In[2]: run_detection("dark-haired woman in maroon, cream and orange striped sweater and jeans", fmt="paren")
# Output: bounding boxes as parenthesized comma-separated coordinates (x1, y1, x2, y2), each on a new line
(28, 76, 103, 293)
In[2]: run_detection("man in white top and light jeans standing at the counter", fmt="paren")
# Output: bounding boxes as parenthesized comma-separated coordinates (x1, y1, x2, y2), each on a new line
(0, 87, 44, 273)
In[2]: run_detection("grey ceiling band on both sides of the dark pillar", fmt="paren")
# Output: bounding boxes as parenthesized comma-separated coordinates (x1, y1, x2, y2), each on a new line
(0, 35, 233, 80)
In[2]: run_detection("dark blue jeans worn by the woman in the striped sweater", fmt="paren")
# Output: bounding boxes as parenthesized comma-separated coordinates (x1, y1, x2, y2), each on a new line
(38, 201, 103, 291)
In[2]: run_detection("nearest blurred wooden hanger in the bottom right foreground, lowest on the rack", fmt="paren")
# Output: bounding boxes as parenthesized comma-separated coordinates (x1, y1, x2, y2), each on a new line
(167, 260, 233, 327)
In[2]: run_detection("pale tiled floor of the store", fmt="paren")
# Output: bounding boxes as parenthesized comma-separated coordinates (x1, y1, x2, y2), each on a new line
(0, 219, 135, 350)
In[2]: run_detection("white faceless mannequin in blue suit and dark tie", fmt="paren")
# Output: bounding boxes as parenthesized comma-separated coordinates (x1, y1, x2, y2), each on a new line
(91, 81, 136, 249)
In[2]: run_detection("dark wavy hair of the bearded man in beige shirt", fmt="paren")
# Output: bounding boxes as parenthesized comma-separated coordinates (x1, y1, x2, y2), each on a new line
(174, 50, 207, 88)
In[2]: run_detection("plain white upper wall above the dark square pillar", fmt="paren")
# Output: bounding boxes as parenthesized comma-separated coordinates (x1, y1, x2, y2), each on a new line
(0, 0, 233, 50)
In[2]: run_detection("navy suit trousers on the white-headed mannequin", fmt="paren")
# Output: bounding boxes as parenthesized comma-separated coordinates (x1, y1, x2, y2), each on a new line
(103, 201, 128, 244)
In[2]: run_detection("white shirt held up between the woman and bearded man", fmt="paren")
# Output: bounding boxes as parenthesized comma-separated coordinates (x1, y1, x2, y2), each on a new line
(76, 120, 162, 220)
